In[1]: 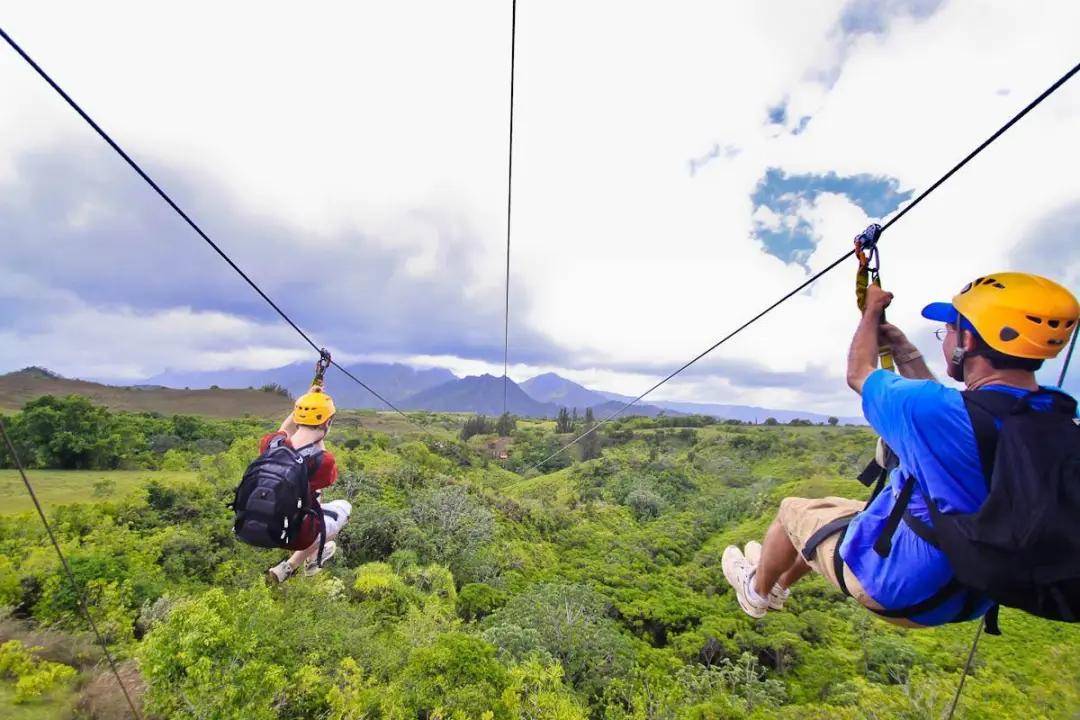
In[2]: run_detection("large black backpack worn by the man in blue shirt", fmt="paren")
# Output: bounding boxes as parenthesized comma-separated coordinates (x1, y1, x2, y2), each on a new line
(928, 391, 1080, 622)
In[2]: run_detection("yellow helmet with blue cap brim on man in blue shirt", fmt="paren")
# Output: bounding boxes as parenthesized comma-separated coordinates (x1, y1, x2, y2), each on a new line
(922, 272, 1080, 359)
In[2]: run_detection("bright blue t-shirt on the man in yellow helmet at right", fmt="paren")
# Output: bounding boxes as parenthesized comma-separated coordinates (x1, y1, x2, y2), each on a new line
(840, 369, 1067, 625)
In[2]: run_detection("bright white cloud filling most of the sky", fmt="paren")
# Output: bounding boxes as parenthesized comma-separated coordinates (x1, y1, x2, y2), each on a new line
(0, 0, 1080, 415)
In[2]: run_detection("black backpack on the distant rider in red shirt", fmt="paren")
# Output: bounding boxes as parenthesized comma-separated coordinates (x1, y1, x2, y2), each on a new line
(230, 437, 326, 563)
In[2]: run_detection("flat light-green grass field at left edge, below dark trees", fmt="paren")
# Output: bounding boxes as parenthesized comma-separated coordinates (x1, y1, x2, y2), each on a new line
(0, 470, 195, 515)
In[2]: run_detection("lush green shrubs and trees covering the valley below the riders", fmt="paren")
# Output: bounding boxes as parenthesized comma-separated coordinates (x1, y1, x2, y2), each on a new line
(0, 397, 1080, 720)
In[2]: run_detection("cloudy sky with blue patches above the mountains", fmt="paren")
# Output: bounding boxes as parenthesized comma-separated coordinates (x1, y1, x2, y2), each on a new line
(0, 0, 1080, 416)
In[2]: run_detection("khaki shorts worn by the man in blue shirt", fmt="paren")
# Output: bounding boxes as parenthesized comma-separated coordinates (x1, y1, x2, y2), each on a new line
(777, 498, 922, 627)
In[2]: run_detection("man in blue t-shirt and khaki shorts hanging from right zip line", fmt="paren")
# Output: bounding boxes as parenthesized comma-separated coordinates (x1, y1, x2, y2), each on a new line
(723, 273, 1080, 627)
